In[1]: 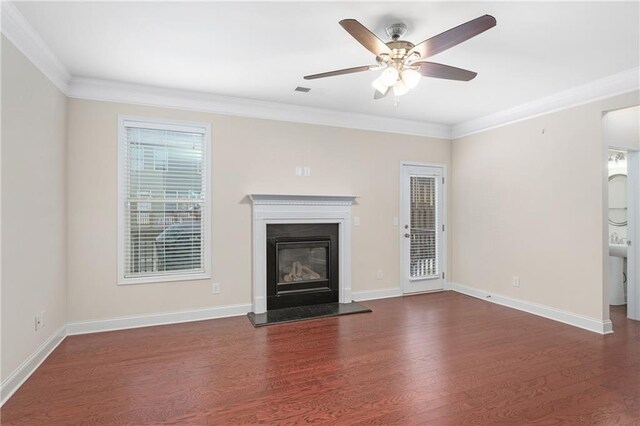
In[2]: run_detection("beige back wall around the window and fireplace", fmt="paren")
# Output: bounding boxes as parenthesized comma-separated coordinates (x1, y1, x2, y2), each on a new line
(67, 99, 450, 322)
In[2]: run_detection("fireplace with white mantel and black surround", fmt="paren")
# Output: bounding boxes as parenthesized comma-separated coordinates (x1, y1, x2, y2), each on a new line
(249, 194, 356, 314)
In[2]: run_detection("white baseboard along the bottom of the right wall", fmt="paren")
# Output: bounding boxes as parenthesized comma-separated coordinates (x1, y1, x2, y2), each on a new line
(451, 283, 613, 334)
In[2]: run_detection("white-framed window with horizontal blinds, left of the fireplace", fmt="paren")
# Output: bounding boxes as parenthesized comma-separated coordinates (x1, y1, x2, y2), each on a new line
(118, 116, 211, 284)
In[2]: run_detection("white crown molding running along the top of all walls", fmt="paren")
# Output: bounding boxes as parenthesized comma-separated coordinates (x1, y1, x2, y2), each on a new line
(1, 1, 640, 140)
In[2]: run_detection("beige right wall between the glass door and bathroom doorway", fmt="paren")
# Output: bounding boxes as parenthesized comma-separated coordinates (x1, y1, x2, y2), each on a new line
(450, 93, 638, 319)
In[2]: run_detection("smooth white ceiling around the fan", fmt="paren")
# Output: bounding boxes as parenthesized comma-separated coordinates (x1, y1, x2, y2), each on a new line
(10, 1, 640, 124)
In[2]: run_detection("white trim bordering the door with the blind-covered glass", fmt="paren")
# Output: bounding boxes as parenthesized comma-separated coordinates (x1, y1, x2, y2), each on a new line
(398, 160, 449, 294)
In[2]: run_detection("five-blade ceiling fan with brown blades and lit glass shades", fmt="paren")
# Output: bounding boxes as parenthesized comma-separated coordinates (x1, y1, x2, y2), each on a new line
(304, 15, 496, 99)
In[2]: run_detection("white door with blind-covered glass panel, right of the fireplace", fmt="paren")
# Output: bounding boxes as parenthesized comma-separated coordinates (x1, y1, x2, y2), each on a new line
(399, 164, 445, 293)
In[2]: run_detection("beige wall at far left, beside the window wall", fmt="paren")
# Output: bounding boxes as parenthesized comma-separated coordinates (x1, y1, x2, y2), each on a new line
(1, 38, 67, 380)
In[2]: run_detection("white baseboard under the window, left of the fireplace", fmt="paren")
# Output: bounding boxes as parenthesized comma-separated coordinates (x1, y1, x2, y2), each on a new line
(67, 304, 251, 336)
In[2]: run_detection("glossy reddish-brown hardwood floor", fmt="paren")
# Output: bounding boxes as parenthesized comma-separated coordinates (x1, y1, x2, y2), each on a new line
(1, 292, 640, 425)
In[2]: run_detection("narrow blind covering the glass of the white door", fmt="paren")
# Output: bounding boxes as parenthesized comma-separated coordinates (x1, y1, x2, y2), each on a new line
(409, 176, 440, 278)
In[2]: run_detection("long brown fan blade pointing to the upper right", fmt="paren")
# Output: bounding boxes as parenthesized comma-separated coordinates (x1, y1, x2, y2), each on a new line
(408, 15, 496, 59)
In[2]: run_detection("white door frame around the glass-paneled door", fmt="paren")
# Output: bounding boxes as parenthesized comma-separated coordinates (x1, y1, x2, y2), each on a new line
(398, 160, 451, 296)
